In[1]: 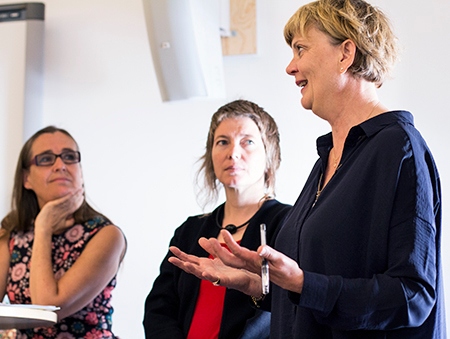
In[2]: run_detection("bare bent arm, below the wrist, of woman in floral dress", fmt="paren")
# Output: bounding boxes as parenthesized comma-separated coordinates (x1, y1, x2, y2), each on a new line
(30, 225, 126, 319)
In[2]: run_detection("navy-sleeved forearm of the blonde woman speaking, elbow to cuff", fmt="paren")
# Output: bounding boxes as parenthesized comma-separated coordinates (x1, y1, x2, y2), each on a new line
(298, 236, 436, 330)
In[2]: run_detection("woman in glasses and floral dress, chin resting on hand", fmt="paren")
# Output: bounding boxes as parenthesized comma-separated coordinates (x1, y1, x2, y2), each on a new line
(0, 126, 126, 339)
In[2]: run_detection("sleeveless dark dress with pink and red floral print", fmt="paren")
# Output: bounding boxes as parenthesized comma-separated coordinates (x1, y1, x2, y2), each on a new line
(6, 217, 118, 339)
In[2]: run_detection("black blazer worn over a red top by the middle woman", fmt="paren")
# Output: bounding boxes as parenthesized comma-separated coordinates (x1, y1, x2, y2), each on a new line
(143, 200, 291, 339)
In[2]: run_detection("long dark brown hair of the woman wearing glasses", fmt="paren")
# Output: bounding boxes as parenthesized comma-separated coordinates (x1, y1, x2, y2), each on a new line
(2, 126, 107, 231)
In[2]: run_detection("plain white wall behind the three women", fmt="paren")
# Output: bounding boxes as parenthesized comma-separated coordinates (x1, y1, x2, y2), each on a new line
(0, 0, 450, 339)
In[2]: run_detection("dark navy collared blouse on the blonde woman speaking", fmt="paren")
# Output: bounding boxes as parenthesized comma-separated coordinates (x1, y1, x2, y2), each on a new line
(271, 111, 446, 339)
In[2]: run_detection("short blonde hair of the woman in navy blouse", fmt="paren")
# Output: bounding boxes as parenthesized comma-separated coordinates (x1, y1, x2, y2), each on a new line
(284, 0, 399, 87)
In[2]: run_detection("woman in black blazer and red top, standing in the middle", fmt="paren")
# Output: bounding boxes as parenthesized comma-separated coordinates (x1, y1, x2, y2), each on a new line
(144, 100, 290, 339)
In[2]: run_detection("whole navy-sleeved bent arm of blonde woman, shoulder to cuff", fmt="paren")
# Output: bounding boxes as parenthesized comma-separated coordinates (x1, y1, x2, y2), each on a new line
(290, 152, 442, 330)
